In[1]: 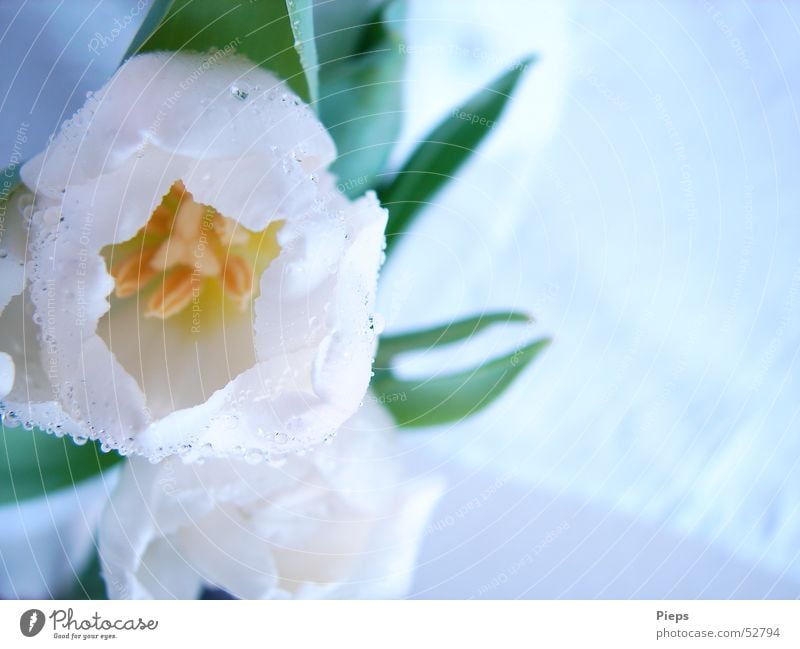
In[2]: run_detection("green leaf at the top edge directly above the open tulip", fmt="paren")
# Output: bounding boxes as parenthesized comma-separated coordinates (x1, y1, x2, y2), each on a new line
(139, 0, 310, 101)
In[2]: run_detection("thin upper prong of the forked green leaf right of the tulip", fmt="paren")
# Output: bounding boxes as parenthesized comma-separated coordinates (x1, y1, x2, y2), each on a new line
(375, 311, 533, 368)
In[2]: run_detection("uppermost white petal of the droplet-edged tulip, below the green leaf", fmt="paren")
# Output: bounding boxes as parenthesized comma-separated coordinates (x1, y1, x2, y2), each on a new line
(22, 52, 335, 198)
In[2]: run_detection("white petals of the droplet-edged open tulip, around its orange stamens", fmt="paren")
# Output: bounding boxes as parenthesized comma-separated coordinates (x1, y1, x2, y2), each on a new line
(18, 54, 386, 459)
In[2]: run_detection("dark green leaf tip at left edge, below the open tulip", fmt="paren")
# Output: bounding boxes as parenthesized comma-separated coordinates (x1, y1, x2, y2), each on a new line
(0, 426, 125, 503)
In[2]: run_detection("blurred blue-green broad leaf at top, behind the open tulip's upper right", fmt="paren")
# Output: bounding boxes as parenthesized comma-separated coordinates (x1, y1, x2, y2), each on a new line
(319, 0, 406, 197)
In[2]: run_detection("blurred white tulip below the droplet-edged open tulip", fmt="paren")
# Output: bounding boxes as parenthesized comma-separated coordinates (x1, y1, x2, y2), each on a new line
(99, 403, 441, 599)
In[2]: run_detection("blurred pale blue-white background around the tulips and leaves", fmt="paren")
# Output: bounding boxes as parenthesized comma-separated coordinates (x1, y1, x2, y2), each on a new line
(0, 0, 800, 598)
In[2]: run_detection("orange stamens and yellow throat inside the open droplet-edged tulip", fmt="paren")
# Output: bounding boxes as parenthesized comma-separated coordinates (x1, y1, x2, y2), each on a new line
(103, 180, 283, 320)
